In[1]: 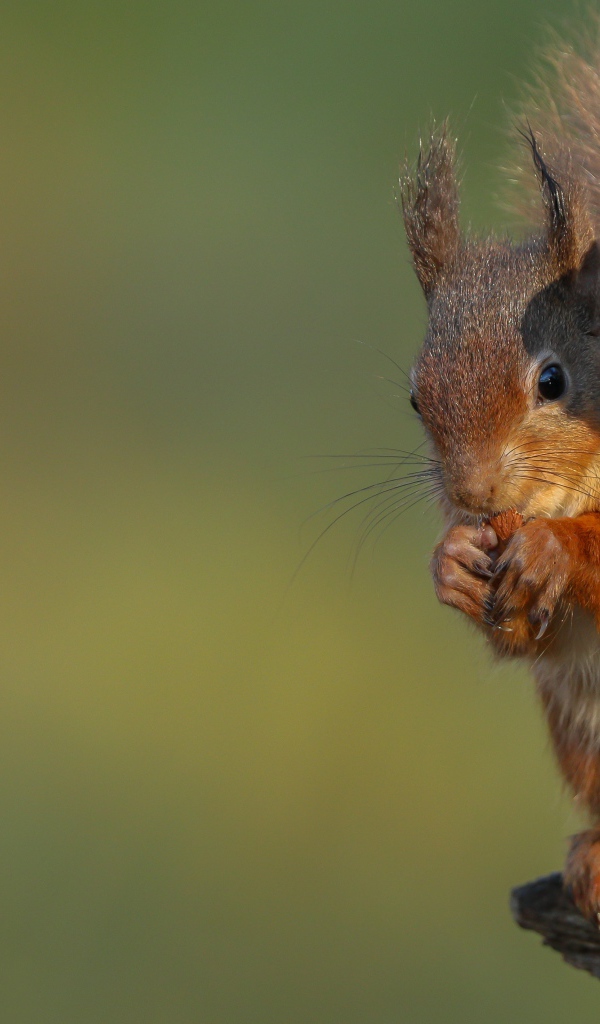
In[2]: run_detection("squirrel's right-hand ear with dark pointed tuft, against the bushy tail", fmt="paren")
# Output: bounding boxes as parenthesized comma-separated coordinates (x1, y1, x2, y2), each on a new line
(521, 125, 594, 276)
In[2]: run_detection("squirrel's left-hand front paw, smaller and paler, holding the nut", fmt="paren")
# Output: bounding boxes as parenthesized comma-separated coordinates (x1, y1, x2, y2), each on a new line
(430, 526, 498, 623)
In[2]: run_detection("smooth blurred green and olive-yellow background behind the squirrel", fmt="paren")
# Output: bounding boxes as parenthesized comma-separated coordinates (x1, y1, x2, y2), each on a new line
(0, 0, 589, 1024)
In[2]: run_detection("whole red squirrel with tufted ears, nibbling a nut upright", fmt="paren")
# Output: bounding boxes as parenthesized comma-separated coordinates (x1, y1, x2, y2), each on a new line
(400, 36, 600, 925)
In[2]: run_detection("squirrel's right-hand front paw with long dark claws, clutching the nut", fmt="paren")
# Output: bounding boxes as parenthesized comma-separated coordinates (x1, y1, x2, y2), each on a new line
(484, 519, 571, 653)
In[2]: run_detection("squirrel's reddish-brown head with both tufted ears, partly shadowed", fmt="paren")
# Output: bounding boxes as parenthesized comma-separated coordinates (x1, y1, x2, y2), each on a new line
(400, 126, 600, 517)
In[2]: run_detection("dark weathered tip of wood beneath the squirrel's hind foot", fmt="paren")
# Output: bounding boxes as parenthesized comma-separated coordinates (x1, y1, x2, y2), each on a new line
(511, 872, 600, 978)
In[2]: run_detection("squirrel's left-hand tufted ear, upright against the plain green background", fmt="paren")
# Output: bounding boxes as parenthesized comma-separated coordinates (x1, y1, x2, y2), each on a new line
(400, 123, 461, 298)
